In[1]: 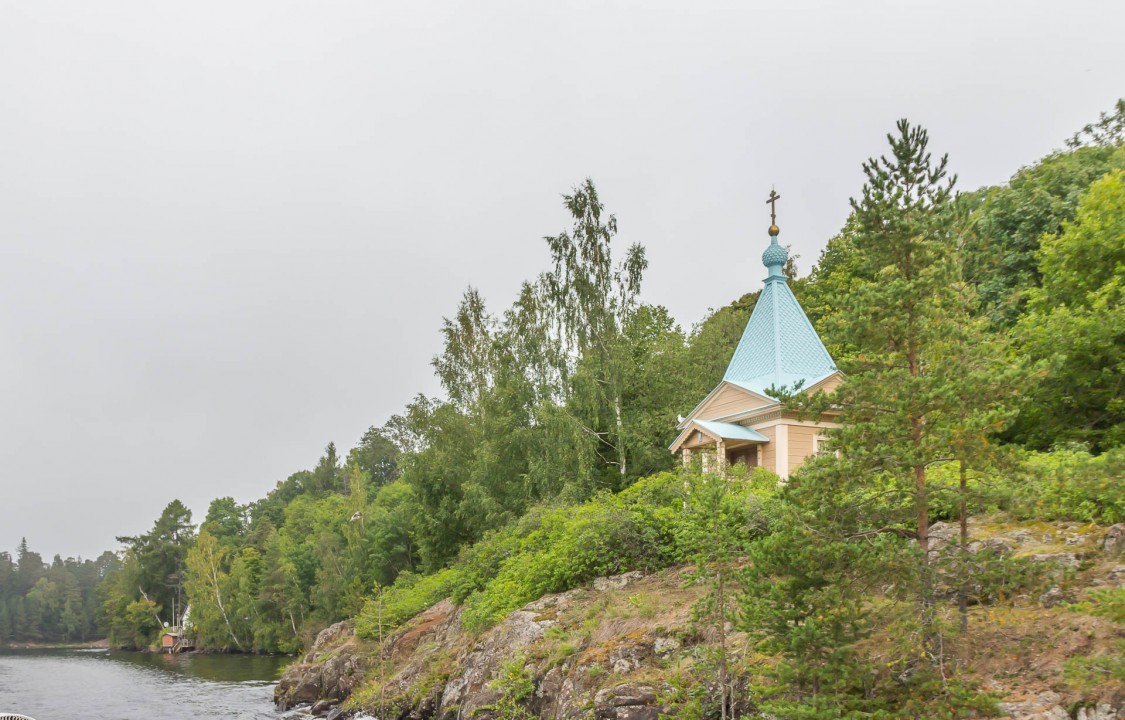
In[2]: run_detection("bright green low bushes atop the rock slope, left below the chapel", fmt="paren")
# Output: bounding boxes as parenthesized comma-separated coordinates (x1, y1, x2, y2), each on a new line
(356, 473, 774, 638)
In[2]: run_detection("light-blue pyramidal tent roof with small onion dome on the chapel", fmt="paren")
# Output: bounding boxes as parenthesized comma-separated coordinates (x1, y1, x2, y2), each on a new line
(722, 228, 836, 395)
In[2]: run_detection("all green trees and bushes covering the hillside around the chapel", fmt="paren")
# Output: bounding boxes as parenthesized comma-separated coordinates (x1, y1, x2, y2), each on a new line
(0, 101, 1125, 717)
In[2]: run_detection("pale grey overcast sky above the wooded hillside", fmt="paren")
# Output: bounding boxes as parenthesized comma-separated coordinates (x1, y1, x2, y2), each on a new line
(0, 0, 1125, 558)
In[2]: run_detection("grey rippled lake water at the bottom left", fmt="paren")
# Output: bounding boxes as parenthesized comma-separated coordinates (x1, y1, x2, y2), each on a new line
(0, 650, 293, 720)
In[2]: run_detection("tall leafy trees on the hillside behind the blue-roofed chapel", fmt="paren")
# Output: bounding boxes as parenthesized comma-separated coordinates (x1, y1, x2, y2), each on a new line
(26, 102, 1125, 651)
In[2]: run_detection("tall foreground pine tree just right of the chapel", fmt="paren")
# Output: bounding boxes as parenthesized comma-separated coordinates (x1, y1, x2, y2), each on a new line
(806, 120, 1014, 662)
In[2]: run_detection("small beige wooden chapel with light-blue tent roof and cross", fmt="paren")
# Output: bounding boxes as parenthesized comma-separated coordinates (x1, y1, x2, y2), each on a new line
(671, 191, 843, 479)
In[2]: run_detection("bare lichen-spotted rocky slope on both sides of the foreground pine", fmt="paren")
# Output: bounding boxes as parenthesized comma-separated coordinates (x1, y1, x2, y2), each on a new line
(276, 523, 1125, 720)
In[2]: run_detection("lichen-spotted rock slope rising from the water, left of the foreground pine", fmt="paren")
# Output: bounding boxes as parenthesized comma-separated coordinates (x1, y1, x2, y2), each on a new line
(275, 573, 679, 720)
